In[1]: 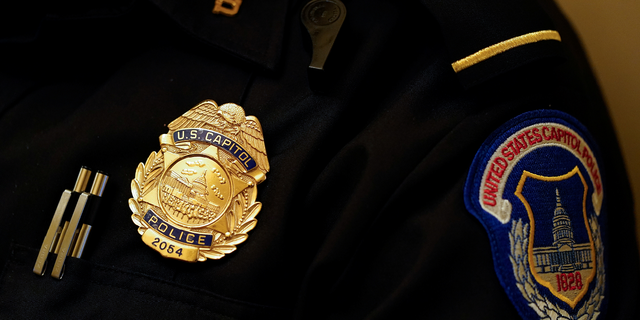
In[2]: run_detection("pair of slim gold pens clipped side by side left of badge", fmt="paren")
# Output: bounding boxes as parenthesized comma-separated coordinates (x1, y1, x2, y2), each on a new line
(33, 167, 109, 279)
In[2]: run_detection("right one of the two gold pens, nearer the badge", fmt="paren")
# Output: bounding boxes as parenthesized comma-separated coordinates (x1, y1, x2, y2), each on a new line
(51, 172, 109, 279)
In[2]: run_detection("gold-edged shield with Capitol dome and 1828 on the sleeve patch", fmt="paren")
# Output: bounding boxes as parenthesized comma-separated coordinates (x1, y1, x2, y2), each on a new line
(515, 167, 596, 308)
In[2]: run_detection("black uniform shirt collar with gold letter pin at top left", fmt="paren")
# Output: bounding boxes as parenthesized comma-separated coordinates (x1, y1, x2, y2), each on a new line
(0, 0, 291, 70)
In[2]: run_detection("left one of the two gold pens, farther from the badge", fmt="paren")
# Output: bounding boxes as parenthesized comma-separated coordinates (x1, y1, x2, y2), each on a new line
(33, 167, 91, 276)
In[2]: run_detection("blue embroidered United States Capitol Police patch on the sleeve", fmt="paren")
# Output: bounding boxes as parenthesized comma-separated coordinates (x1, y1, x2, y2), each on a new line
(465, 110, 606, 320)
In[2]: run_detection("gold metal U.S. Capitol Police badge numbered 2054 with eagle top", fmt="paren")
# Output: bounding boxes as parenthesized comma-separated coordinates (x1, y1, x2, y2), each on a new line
(129, 100, 269, 262)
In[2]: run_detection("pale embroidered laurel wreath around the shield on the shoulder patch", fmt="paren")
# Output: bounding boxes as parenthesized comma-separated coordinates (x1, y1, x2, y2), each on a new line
(509, 219, 605, 320)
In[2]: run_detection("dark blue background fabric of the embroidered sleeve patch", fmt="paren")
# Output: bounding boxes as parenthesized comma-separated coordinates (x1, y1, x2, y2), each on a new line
(465, 110, 608, 319)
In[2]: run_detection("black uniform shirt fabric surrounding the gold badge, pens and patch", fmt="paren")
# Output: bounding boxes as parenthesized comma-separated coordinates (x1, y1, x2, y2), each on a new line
(0, 0, 640, 319)
